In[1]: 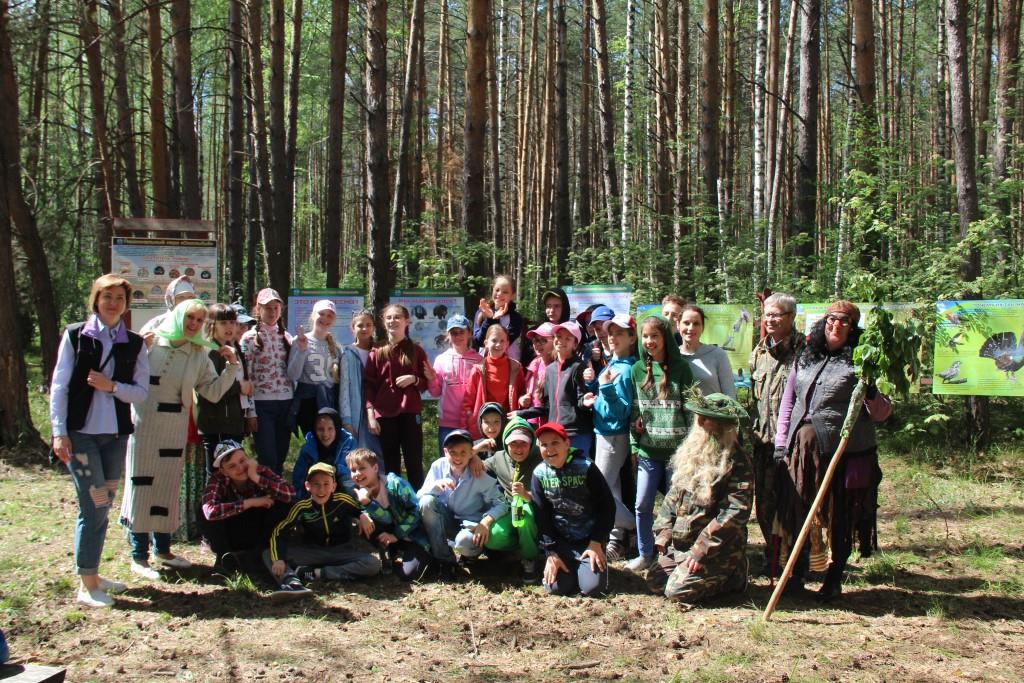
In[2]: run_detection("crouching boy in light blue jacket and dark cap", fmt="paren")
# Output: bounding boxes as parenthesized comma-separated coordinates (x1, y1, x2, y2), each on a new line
(419, 429, 508, 581)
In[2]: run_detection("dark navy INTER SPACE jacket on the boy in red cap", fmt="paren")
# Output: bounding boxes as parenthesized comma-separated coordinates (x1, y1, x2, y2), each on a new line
(530, 449, 615, 554)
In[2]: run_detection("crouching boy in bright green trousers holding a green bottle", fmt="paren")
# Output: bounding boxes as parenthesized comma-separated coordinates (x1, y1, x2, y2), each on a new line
(483, 417, 541, 584)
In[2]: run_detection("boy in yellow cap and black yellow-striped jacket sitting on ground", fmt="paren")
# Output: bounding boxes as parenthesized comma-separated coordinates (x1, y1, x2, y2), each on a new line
(263, 463, 381, 600)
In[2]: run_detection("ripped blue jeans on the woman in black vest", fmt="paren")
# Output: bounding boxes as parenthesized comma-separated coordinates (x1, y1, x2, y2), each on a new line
(68, 431, 128, 577)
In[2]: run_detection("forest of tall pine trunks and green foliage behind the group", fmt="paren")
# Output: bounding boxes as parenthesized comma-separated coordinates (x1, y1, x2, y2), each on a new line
(0, 0, 1024, 454)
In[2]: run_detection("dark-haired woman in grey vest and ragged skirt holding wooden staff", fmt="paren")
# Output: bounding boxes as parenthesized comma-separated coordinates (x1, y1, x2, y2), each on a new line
(775, 300, 892, 601)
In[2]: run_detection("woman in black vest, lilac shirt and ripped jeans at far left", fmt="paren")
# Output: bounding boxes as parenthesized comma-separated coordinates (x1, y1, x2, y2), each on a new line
(50, 274, 150, 607)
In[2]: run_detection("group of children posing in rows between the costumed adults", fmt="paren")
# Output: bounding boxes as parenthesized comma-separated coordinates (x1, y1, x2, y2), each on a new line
(188, 276, 749, 596)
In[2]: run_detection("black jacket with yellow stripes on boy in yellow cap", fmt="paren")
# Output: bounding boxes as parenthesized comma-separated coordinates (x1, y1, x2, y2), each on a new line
(270, 492, 362, 561)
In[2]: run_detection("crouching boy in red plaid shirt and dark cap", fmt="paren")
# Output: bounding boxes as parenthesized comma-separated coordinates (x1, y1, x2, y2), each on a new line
(203, 440, 295, 570)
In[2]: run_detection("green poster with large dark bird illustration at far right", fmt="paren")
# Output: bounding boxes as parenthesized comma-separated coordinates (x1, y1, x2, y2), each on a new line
(932, 299, 1024, 396)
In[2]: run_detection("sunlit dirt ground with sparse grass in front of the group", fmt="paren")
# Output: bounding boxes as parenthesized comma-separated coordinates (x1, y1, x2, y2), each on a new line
(0, 448, 1024, 681)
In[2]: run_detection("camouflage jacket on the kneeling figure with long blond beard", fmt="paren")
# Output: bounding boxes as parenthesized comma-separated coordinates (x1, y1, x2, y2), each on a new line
(654, 446, 754, 568)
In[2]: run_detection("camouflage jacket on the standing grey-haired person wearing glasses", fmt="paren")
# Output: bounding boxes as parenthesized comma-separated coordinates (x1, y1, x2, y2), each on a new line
(751, 330, 806, 445)
